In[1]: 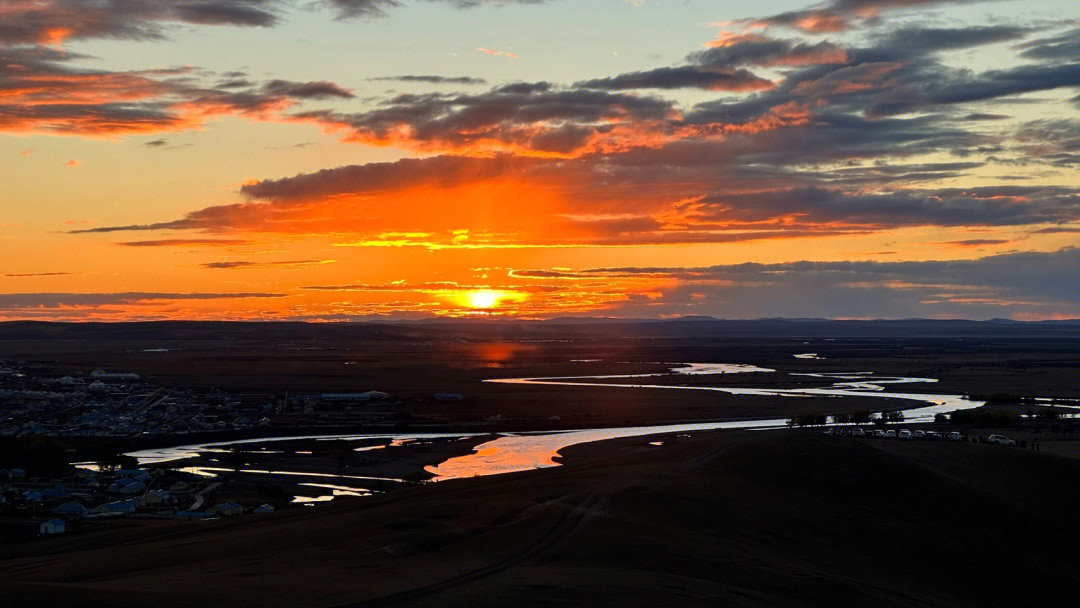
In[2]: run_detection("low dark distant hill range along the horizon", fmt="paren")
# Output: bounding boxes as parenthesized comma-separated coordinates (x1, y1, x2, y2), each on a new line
(0, 316, 1080, 341)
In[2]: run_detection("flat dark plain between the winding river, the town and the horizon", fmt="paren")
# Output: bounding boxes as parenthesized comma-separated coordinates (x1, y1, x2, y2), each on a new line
(0, 321, 1080, 430)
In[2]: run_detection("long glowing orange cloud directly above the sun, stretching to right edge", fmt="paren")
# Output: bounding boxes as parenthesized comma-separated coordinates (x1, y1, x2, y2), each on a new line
(69, 150, 1080, 248)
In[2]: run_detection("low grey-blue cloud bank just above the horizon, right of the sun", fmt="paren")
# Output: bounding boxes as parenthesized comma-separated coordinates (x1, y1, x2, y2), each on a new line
(514, 248, 1080, 319)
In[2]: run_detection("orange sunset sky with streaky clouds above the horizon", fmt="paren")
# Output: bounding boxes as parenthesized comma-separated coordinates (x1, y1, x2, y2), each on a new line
(0, 0, 1080, 321)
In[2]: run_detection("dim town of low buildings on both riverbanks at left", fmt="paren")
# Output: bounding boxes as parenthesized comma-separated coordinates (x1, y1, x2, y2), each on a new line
(0, 361, 412, 536)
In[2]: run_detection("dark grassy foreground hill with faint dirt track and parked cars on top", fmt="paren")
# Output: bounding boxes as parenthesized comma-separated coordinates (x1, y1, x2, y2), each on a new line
(0, 432, 1080, 607)
